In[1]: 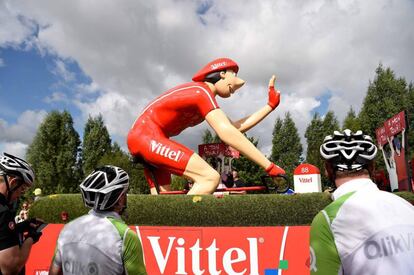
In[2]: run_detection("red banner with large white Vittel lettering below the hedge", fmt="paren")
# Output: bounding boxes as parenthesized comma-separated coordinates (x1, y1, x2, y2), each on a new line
(26, 224, 310, 275)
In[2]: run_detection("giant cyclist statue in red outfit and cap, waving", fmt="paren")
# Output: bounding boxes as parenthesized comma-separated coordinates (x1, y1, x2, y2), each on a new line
(127, 58, 285, 194)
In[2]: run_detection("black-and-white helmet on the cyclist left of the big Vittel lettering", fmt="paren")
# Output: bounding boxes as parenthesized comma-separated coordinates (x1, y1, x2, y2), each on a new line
(80, 165, 129, 210)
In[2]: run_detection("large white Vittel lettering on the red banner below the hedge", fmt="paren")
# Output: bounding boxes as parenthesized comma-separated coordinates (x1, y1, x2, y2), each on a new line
(147, 236, 259, 275)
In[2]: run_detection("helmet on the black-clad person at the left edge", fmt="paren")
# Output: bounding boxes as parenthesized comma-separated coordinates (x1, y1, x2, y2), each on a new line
(0, 153, 35, 185)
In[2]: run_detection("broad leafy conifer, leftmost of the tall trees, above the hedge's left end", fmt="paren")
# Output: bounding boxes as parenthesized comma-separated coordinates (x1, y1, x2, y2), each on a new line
(26, 111, 81, 194)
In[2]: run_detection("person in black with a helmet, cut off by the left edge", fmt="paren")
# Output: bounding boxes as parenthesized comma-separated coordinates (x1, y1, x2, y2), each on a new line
(0, 153, 42, 274)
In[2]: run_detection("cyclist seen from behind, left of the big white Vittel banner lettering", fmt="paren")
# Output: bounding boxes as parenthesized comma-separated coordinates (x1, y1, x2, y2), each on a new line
(49, 166, 147, 275)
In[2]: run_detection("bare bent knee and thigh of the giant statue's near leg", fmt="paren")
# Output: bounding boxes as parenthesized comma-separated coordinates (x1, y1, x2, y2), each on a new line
(183, 153, 220, 195)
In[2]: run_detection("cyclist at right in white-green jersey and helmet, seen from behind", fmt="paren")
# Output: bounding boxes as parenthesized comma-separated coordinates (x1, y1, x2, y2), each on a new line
(310, 129, 414, 275)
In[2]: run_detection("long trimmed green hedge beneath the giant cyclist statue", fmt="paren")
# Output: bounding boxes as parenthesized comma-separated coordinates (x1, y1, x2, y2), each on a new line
(30, 192, 414, 226)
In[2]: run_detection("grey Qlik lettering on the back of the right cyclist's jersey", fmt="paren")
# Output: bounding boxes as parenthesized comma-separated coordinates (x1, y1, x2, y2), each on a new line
(364, 233, 414, 260)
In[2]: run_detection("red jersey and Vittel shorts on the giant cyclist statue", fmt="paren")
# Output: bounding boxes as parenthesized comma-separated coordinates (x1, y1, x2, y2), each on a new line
(127, 82, 219, 188)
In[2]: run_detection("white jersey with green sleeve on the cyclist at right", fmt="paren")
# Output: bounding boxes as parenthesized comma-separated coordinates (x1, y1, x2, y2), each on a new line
(310, 179, 414, 275)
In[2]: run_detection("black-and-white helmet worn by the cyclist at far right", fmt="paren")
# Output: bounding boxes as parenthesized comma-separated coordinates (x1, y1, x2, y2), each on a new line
(320, 129, 378, 171)
